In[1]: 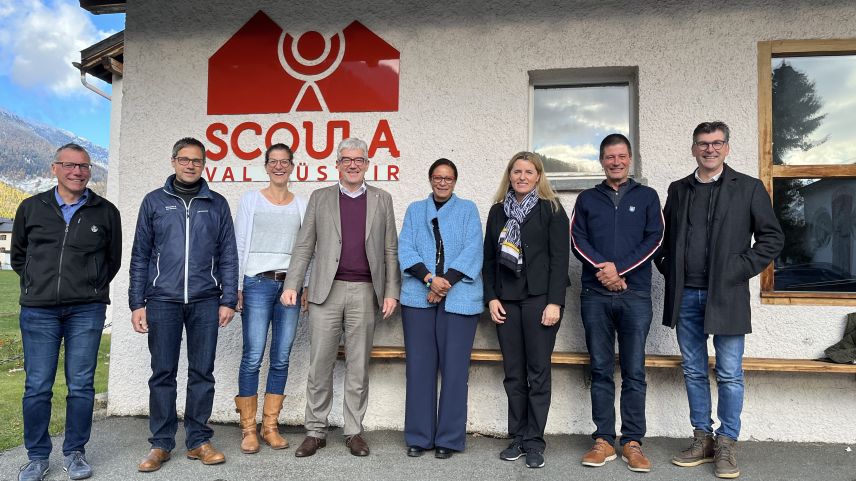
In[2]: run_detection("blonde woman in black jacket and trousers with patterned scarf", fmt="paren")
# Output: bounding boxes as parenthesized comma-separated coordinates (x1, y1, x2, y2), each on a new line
(482, 152, 570, 468)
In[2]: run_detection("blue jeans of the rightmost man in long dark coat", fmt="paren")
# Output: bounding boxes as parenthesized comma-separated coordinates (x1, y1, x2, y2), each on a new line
(677, 287, 745, 439)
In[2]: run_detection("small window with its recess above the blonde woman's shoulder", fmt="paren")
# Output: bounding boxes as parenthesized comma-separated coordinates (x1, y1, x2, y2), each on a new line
(529, 67, 639, 190)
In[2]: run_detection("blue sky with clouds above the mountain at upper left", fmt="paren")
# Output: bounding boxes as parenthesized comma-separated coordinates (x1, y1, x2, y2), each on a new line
(0, 0, 125, 148)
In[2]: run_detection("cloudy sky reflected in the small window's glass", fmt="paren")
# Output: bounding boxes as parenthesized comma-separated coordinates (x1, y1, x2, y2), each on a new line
(532, 85, 630, 174)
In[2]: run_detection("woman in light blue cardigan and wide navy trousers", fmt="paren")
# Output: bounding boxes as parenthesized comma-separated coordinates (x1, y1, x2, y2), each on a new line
(398, 159, 484, 459)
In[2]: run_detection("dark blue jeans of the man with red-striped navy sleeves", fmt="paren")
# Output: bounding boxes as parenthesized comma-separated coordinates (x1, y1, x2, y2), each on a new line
(580, 288, 652, 446)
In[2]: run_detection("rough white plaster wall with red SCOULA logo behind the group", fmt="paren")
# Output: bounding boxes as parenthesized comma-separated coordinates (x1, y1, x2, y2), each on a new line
(98, 0, 856, 443)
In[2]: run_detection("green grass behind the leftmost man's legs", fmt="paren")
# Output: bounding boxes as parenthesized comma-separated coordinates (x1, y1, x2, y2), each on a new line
(0, 271, 110, 451)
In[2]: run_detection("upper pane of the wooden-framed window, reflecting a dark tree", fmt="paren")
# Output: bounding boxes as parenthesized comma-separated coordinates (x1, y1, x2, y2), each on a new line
(772, 55, 856, 165)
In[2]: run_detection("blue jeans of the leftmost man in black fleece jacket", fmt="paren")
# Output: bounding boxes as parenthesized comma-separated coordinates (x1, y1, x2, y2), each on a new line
(19, 303, 107, 460)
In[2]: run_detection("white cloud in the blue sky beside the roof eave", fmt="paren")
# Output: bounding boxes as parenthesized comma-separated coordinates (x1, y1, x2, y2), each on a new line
(0, 0, 107, 96)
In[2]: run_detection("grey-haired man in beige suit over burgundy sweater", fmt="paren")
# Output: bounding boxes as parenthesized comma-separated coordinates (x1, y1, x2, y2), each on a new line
(282, 138, 401, 457)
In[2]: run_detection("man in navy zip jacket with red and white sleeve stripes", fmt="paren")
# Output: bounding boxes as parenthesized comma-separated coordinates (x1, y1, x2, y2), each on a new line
(571, 134, 664, 472)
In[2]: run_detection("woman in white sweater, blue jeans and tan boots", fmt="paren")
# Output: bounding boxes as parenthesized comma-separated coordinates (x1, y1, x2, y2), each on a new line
(235, 144, 306, 454)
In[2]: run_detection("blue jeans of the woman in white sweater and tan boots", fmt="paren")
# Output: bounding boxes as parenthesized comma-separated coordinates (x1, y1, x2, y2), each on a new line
(238, 276, 300, 396)
